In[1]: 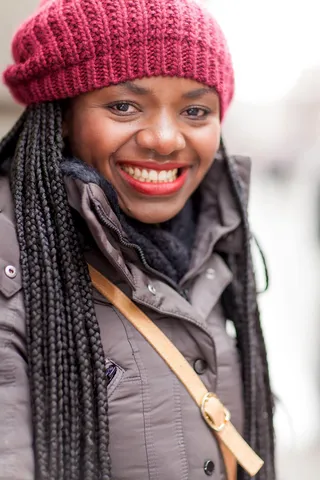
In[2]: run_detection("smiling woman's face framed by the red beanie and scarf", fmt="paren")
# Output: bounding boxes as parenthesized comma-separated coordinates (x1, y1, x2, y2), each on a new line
(64, 77, 220, 223)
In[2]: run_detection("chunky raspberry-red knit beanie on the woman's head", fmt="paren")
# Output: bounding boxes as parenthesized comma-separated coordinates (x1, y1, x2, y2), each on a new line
(4, 0, 234, 118)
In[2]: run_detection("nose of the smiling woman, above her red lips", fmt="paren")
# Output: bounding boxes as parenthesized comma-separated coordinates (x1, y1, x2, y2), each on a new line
(136, 114, 186, 156)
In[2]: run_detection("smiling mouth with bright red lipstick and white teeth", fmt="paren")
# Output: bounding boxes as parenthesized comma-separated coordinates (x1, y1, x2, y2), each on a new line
(118, 163, 190, 196)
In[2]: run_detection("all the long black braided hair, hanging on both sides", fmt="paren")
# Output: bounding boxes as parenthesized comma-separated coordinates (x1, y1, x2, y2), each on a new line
(0, 102, 275, 480)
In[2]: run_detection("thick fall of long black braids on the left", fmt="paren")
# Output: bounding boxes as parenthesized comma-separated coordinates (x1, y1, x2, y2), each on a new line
(0, 103, 110, 480)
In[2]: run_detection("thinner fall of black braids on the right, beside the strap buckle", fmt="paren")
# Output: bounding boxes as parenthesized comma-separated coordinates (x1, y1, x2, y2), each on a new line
(220, 142, 276, 480)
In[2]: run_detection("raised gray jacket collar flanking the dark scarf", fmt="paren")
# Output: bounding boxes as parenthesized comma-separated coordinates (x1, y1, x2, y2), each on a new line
(62, 155, 251, 288)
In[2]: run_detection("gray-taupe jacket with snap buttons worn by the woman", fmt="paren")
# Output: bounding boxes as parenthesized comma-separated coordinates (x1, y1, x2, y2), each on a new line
(0, 158, 250, 480)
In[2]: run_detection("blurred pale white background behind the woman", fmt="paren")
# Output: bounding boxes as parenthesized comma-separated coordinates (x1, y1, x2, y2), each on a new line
(0, 0, 320, 480)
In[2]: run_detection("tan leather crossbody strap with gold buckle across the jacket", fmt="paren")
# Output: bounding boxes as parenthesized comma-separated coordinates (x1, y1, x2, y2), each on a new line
(89, 265, 263, 480)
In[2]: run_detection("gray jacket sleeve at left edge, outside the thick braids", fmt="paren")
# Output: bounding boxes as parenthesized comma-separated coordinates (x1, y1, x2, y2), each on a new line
(0, 177, 34, 480)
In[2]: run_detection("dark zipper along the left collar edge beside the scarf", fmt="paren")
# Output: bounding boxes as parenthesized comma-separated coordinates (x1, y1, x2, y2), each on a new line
(93, 201, 189, 301)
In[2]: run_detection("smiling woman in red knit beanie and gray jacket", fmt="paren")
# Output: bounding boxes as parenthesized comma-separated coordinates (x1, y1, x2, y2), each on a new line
(0, 0, 274, 480)
